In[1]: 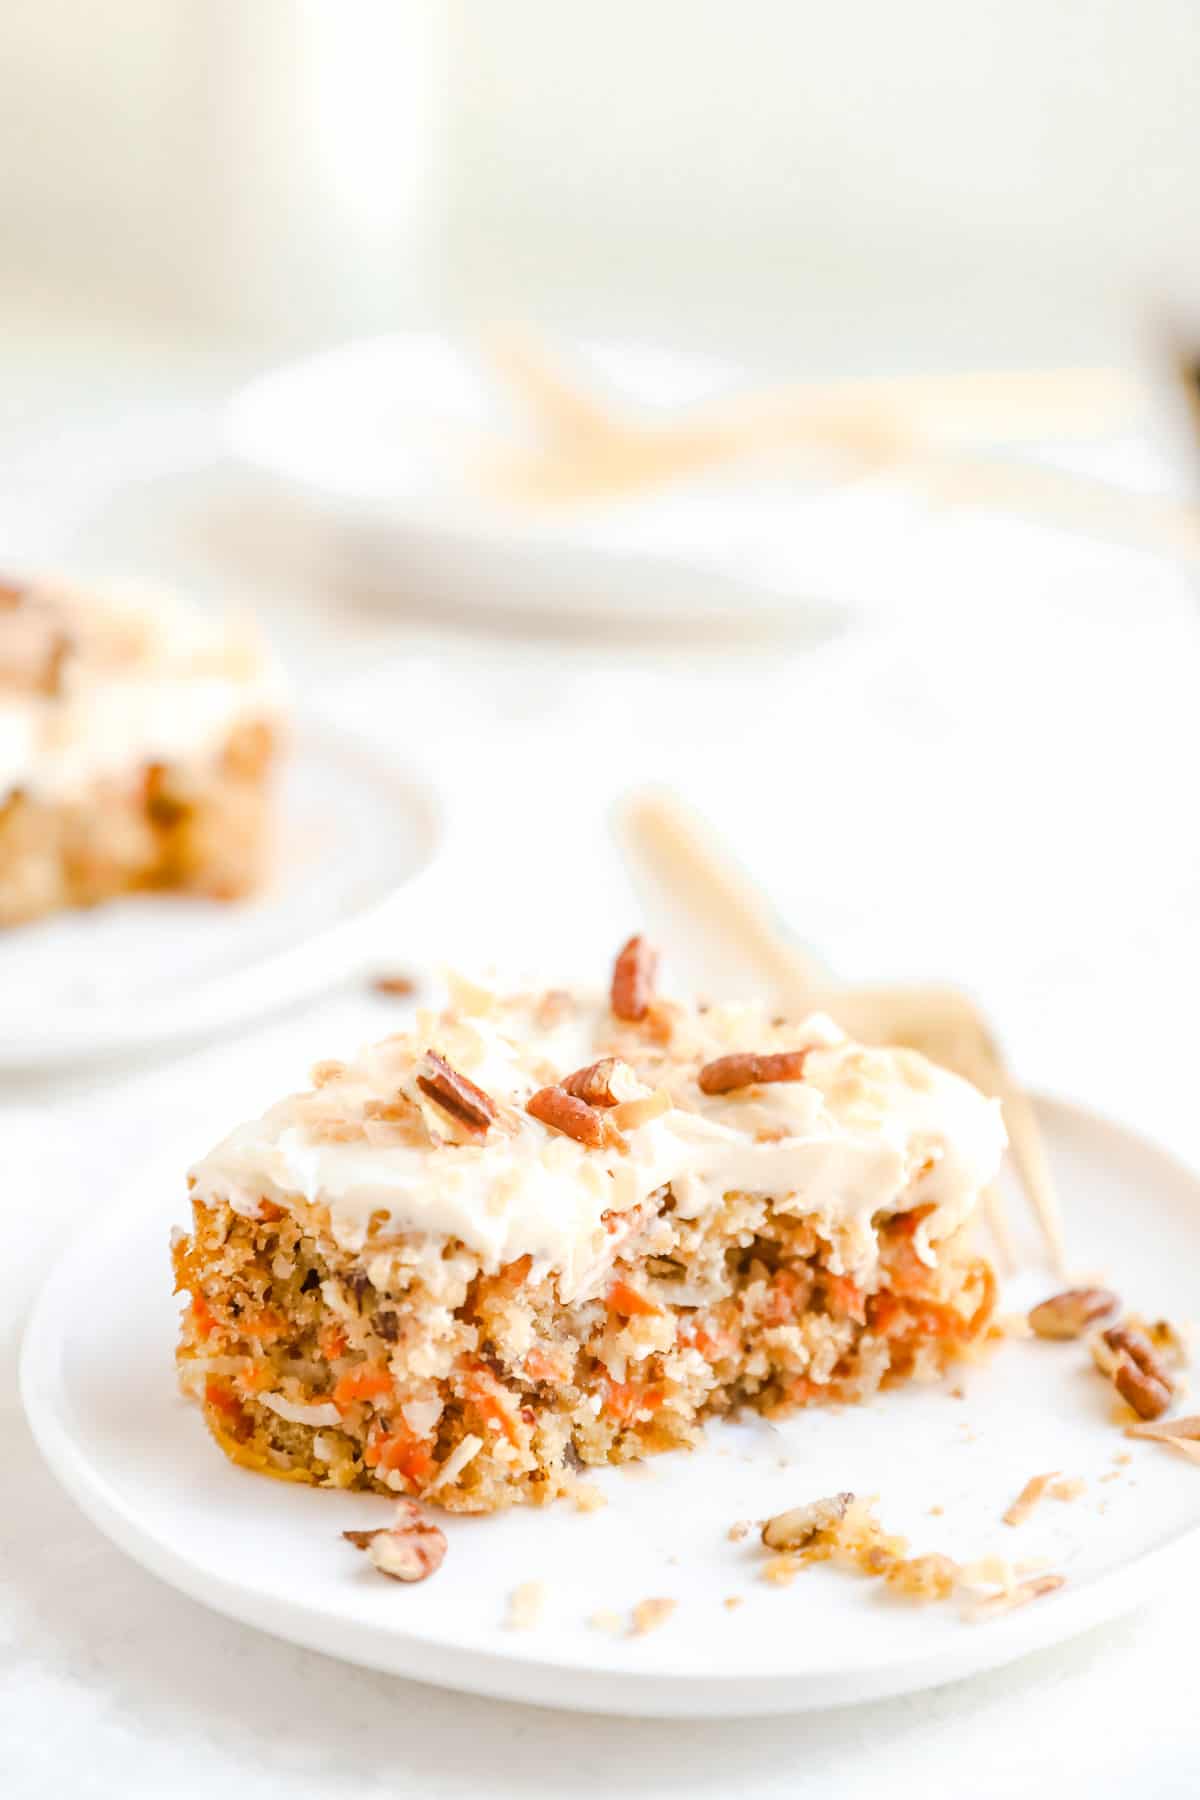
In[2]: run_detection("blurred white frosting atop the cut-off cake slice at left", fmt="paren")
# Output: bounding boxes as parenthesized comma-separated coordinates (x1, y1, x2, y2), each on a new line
(0, 585, 282, 799)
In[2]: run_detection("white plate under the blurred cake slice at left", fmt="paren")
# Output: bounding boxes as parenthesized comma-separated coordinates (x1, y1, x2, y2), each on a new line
(0, 725, 443, 1069)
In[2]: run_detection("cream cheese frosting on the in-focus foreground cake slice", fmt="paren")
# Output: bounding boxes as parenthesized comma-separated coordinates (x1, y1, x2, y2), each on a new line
(191, 983, 1006, 1300)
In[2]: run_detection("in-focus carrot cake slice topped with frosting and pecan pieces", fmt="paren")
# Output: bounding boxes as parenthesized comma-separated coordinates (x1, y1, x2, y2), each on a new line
(175, 940, 1004, 1512)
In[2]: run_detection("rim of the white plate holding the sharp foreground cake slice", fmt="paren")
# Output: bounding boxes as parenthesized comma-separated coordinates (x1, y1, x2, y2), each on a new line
(20, 1098, 1200, 1717)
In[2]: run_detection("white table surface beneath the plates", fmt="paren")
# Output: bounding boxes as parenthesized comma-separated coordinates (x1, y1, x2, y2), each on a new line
(0, 316, 1200, 1800)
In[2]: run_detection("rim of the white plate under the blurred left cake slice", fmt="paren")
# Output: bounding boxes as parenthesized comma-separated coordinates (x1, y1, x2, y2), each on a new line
(0, 718, 446, 1073)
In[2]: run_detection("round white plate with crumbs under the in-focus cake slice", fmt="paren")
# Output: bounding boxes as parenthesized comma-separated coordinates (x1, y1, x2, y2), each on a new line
(22, 1102, 1200, 1717)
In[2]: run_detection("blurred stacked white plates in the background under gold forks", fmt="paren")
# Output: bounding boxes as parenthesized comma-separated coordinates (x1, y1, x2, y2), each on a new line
(227, 333, 847, 635)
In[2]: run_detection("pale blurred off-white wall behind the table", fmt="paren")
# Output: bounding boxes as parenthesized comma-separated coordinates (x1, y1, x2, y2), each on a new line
(0, 0, 1200, 367)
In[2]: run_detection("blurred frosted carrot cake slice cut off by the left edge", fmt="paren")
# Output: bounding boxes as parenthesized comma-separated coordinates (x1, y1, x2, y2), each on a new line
(0, 581, 281, 925)
